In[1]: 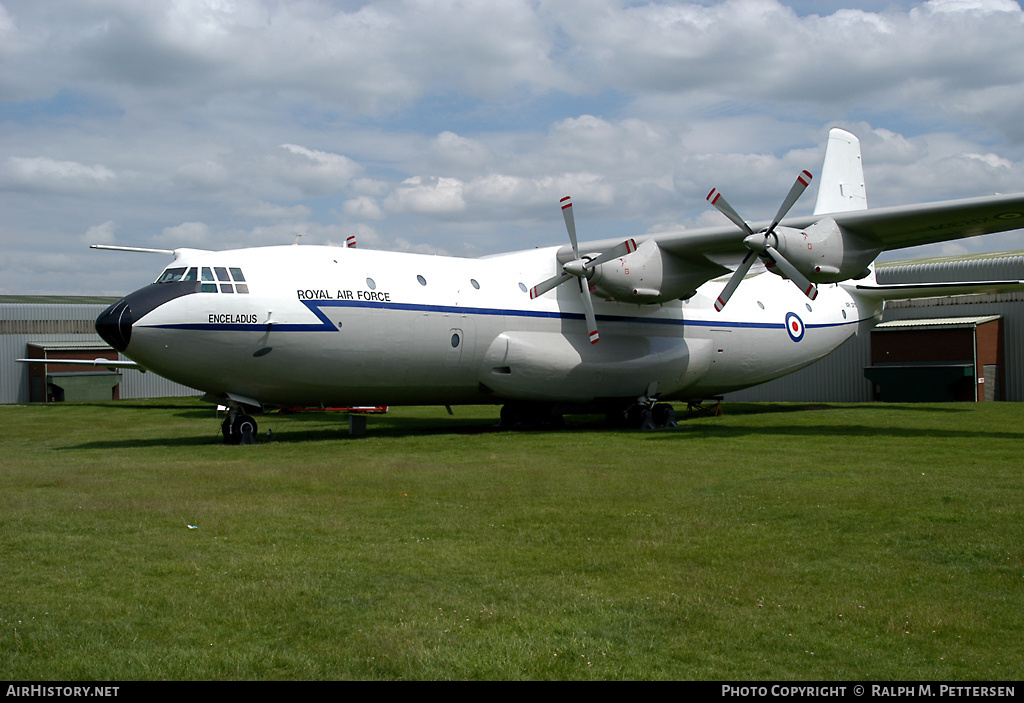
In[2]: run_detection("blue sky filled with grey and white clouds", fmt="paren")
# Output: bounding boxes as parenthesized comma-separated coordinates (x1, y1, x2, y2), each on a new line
(0, 0, 1024, 295)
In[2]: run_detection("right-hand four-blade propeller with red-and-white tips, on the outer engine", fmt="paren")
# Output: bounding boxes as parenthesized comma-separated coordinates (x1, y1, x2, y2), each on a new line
(708, 171, 818, 312)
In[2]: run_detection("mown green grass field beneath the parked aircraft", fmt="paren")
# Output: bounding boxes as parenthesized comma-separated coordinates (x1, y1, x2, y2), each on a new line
(0, 400, 1024, 680)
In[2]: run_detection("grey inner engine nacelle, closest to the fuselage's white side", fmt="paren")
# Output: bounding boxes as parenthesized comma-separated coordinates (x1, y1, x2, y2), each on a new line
(590, 239, 718, 304)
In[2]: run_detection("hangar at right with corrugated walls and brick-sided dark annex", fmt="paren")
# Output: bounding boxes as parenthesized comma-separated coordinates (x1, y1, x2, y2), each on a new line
(725, 253, 1024, 402)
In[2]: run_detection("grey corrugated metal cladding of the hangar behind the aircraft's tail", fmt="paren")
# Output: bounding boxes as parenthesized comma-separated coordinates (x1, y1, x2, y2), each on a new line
(726, 255, 1024, 402)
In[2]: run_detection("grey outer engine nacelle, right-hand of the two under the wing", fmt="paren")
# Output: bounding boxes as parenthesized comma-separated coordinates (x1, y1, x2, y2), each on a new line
(769, 217, 882, 283)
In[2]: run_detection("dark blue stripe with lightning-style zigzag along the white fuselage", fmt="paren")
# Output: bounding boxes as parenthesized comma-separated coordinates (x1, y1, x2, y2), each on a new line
(140, 300, 861, 332)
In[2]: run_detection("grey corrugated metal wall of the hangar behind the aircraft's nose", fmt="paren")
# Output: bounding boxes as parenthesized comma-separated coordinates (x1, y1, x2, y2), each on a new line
(0, 297, 199, 403)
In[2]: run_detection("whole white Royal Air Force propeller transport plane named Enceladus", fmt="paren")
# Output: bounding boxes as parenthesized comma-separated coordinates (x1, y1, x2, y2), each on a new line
(68, 129, 1024, 443)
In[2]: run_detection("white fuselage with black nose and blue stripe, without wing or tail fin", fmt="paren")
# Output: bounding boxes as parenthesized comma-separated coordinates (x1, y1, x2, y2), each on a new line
(97, 247, 880, 413)
